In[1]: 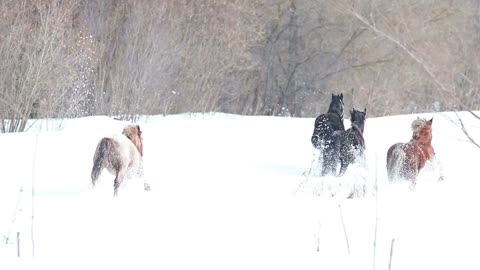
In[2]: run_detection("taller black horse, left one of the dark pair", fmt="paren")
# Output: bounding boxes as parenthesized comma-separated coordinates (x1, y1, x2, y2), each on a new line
(311, 93, 345, 176)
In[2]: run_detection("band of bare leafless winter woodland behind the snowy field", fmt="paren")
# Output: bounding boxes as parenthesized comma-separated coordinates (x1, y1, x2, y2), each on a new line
(0, 0, 480, 132)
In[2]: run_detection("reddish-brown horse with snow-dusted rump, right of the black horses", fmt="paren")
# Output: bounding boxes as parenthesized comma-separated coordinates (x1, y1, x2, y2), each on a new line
(387, 118, 435, 185)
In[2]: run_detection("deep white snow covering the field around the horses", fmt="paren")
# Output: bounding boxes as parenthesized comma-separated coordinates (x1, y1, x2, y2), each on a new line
(0, 110, 480, 269)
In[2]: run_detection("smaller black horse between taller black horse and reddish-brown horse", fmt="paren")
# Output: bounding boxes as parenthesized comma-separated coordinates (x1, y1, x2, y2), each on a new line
(337, 108, 367, 176)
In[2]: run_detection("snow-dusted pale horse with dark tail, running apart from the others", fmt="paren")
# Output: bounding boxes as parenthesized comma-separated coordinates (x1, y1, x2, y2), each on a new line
(91, 124, 150, 196)
